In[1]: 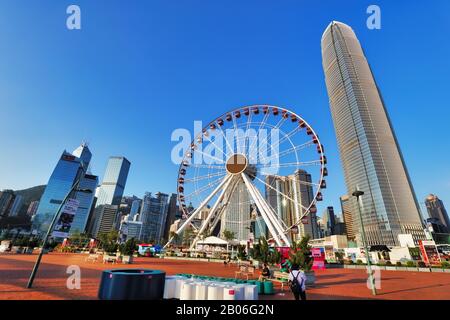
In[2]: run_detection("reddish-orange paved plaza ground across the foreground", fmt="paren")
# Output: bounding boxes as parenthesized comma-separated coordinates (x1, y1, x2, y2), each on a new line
(0, 253, 450, 300)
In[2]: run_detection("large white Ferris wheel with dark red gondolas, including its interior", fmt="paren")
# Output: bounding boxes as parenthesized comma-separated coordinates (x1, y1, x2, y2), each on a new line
(166, 105, 328, 248)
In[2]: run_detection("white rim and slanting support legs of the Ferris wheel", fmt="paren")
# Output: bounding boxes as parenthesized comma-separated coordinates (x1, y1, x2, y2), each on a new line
(164, 105, 328, 249)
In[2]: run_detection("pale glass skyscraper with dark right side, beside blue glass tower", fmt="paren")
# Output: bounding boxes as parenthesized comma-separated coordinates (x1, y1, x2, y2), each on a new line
(96, 157, 131, 206)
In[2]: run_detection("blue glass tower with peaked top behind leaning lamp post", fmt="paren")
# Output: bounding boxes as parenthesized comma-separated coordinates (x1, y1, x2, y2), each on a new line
(32, 144, 96, 235)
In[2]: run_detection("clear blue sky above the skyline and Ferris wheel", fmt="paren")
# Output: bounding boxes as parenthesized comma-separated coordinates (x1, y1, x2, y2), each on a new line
(0, 0, 450, 218)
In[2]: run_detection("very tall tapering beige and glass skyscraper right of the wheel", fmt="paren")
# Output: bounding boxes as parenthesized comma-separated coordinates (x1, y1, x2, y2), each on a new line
(322, 22, 425, 245)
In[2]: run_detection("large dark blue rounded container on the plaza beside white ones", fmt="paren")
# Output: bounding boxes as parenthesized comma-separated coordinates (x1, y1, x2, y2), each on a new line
(98, 269, 166, 300)
